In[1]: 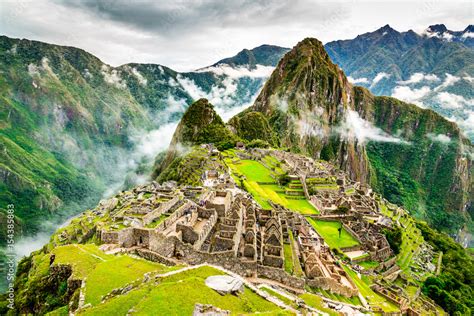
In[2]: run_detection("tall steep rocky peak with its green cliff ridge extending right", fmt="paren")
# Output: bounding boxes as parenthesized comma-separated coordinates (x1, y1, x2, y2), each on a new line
(237, 38, 473, 229)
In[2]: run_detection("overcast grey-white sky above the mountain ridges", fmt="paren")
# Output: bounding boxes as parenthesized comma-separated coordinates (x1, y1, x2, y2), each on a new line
(0, 0, 474, 71)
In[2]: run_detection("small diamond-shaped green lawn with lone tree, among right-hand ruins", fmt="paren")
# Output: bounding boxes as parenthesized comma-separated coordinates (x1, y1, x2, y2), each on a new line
(306, 217, 359, 249)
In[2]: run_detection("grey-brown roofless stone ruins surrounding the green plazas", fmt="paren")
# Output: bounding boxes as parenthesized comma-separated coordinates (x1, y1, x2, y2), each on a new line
(93, 146, 408, 297)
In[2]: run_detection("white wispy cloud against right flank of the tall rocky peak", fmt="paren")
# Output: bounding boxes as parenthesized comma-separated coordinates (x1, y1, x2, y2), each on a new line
(337, 110, 408, 144)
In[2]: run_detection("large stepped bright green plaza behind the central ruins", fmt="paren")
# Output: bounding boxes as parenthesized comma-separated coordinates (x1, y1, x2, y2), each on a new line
(223, 150, 318, 214)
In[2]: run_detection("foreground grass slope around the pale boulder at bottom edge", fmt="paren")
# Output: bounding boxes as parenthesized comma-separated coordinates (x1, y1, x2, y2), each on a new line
(83, 267, 284, 315)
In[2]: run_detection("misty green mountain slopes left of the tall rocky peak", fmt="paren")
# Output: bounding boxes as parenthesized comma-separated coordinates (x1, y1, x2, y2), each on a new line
(0, 36, 280, 260)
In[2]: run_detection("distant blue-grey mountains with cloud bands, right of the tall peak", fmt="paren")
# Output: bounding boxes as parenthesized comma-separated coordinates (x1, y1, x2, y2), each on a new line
(325, 24, 474, 140)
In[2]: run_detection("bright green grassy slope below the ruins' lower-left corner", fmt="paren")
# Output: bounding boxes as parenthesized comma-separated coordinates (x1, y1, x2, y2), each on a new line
(53, 244, 181, 305)
